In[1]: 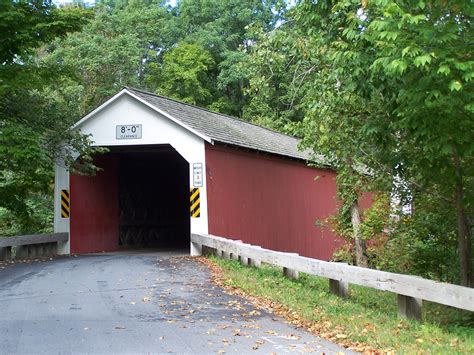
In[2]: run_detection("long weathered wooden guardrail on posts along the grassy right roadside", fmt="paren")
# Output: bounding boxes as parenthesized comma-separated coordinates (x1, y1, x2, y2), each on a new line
(191, 234, 474, 319)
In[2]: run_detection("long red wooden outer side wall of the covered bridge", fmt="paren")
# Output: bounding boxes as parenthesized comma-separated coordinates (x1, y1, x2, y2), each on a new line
(206, 144, 342, 260)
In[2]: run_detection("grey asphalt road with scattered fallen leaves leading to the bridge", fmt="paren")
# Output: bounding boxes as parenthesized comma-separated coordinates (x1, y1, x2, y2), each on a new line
(0, 253, 348, 354)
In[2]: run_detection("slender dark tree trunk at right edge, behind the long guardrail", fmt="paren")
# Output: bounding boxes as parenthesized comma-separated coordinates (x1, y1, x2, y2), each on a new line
(453, 152, 472, 287)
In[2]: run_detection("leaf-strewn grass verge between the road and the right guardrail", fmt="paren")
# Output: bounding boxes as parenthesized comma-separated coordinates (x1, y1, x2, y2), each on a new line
(208, 256, 474, 354)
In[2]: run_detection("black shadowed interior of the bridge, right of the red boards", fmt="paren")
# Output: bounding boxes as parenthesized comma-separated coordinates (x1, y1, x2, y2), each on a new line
(112, 145, 190, 248)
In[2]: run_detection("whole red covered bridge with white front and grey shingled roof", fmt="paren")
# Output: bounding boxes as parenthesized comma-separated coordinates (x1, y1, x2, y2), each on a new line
(54, 88, 341, 260)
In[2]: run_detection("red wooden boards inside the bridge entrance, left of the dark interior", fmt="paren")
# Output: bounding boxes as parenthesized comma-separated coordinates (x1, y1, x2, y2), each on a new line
(70, 155, 119, 253)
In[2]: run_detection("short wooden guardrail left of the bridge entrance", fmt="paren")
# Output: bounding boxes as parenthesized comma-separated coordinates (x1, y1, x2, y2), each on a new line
(0, 233, 69, 260)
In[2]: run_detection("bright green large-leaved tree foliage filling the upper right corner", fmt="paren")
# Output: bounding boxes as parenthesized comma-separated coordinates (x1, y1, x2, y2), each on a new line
(296, 1, 474, 203)
